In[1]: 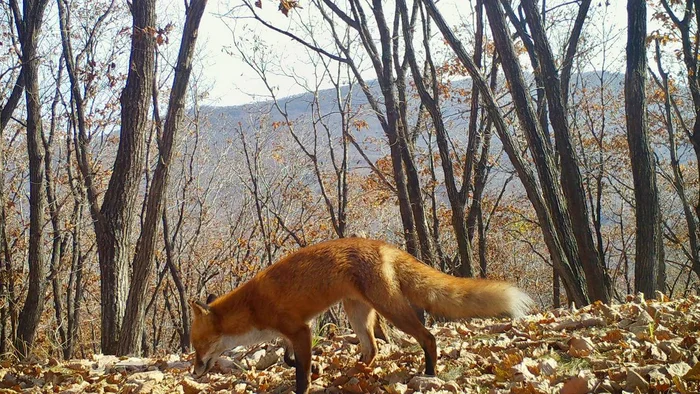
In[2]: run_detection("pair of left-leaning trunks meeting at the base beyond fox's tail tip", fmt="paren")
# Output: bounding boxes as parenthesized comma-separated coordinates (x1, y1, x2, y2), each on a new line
(423, 0, 600, 305)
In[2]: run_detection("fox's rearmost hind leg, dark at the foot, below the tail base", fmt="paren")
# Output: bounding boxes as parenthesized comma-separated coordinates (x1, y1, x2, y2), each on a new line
(374, 296, 437, 375)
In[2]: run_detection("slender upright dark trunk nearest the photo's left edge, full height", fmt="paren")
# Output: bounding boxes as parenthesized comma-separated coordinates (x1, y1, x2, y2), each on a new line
(15, 0, 48, 358)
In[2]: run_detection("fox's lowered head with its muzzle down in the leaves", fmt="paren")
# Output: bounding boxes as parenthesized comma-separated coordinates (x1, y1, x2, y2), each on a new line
(190, 301, 228, 377)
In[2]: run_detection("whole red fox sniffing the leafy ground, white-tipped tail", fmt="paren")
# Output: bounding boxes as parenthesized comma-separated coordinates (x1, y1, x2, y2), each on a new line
(190, 238, 532, 394)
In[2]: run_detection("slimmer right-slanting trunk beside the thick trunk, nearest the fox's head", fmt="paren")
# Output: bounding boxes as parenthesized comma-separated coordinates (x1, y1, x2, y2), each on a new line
(118, 0, 207, 355)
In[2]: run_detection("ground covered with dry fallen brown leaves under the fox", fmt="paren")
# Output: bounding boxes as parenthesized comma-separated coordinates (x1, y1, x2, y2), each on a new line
(0, 296, 700, 394)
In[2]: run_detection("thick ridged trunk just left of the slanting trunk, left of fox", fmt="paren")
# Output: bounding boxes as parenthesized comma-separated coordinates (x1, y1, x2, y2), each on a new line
(95, 0, 156, 354)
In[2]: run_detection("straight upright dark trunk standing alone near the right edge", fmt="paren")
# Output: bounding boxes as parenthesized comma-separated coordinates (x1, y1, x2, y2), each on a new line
(625, 0, 663, 298)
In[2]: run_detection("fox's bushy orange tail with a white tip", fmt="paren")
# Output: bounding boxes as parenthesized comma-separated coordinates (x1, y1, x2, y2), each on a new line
(397, 255, 533, 319)
